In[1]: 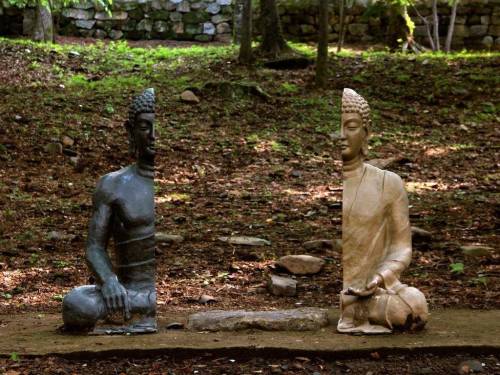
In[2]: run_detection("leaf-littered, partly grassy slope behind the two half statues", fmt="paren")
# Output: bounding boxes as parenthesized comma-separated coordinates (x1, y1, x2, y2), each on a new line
(0, 35, 500, 374)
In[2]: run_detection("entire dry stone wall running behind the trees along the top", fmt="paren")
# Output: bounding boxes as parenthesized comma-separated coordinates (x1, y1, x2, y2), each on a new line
(0, 0, 500, 49)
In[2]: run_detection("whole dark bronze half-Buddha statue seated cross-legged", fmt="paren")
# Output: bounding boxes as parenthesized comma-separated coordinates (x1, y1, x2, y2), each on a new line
(63, 89, 157, 334)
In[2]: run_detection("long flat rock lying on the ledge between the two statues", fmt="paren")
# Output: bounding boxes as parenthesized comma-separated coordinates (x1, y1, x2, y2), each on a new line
(187, 308, 328, 331)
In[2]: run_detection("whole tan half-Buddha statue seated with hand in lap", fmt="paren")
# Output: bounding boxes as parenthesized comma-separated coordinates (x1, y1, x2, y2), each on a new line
(337, 89, 428, 334)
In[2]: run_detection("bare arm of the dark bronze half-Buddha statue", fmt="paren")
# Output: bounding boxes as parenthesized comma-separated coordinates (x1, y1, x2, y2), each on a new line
(86, 178, 116, 284)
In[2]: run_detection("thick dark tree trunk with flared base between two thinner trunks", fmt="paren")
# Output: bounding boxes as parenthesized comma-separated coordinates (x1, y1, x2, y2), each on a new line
(260, 0, 290, 57)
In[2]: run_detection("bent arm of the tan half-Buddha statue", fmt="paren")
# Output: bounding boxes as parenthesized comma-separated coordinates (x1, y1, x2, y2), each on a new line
(377, 172, 412, 288)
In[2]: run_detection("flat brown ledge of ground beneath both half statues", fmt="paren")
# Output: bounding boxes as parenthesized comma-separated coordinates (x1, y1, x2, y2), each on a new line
(0, 310, 500, 358)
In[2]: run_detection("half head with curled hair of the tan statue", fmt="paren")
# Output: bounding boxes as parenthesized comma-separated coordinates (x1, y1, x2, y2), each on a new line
(340, 88, 371, 162)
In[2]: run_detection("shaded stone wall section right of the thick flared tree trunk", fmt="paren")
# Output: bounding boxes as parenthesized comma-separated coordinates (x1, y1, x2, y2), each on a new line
(278, 0, 500, 49)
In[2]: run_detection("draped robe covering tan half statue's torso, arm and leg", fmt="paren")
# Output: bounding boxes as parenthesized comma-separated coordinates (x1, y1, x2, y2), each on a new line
(341, 164, 427, 329)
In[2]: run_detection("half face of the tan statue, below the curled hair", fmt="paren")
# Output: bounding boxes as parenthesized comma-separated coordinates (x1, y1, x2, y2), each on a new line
(340, 113, 367, 161)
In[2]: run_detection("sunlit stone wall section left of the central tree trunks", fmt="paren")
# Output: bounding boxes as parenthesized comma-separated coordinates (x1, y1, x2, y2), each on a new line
(60, 0, 233, 42)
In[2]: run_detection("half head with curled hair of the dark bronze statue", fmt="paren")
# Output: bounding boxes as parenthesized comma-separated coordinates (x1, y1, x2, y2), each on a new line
(125, 88, 155, 161)
